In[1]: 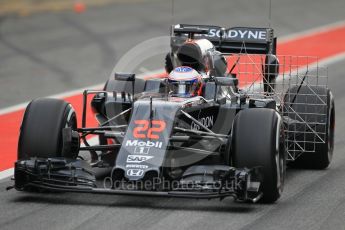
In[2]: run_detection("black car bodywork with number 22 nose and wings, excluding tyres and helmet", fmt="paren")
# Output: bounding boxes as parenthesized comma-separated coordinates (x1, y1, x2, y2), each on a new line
(15, 25, 277, 201)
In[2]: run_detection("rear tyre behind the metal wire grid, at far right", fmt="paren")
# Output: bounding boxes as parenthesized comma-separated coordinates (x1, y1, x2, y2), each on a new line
(284, 86, 335, 169)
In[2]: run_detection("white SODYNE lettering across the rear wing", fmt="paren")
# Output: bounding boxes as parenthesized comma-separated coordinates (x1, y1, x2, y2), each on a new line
(208, 29, 267, 40)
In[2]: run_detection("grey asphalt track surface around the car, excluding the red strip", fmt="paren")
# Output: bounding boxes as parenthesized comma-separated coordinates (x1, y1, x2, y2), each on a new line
(0, 0, 345, 229)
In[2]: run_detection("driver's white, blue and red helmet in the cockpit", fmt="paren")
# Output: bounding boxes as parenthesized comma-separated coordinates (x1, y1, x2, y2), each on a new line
(168, 66, 202, 97)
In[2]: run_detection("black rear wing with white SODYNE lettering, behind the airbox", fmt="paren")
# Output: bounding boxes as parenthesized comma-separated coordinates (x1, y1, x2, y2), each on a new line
(171, 24, 277, 54)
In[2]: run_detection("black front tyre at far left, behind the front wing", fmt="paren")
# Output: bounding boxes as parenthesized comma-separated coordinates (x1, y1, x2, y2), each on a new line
(18, 98, 77, 160)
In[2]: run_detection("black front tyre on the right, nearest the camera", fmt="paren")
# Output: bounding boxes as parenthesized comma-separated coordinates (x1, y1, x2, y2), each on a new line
(231, 108, 286, 203)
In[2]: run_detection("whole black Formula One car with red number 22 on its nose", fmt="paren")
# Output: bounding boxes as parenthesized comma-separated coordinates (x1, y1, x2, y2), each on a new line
(14, 24, 335, 203)
